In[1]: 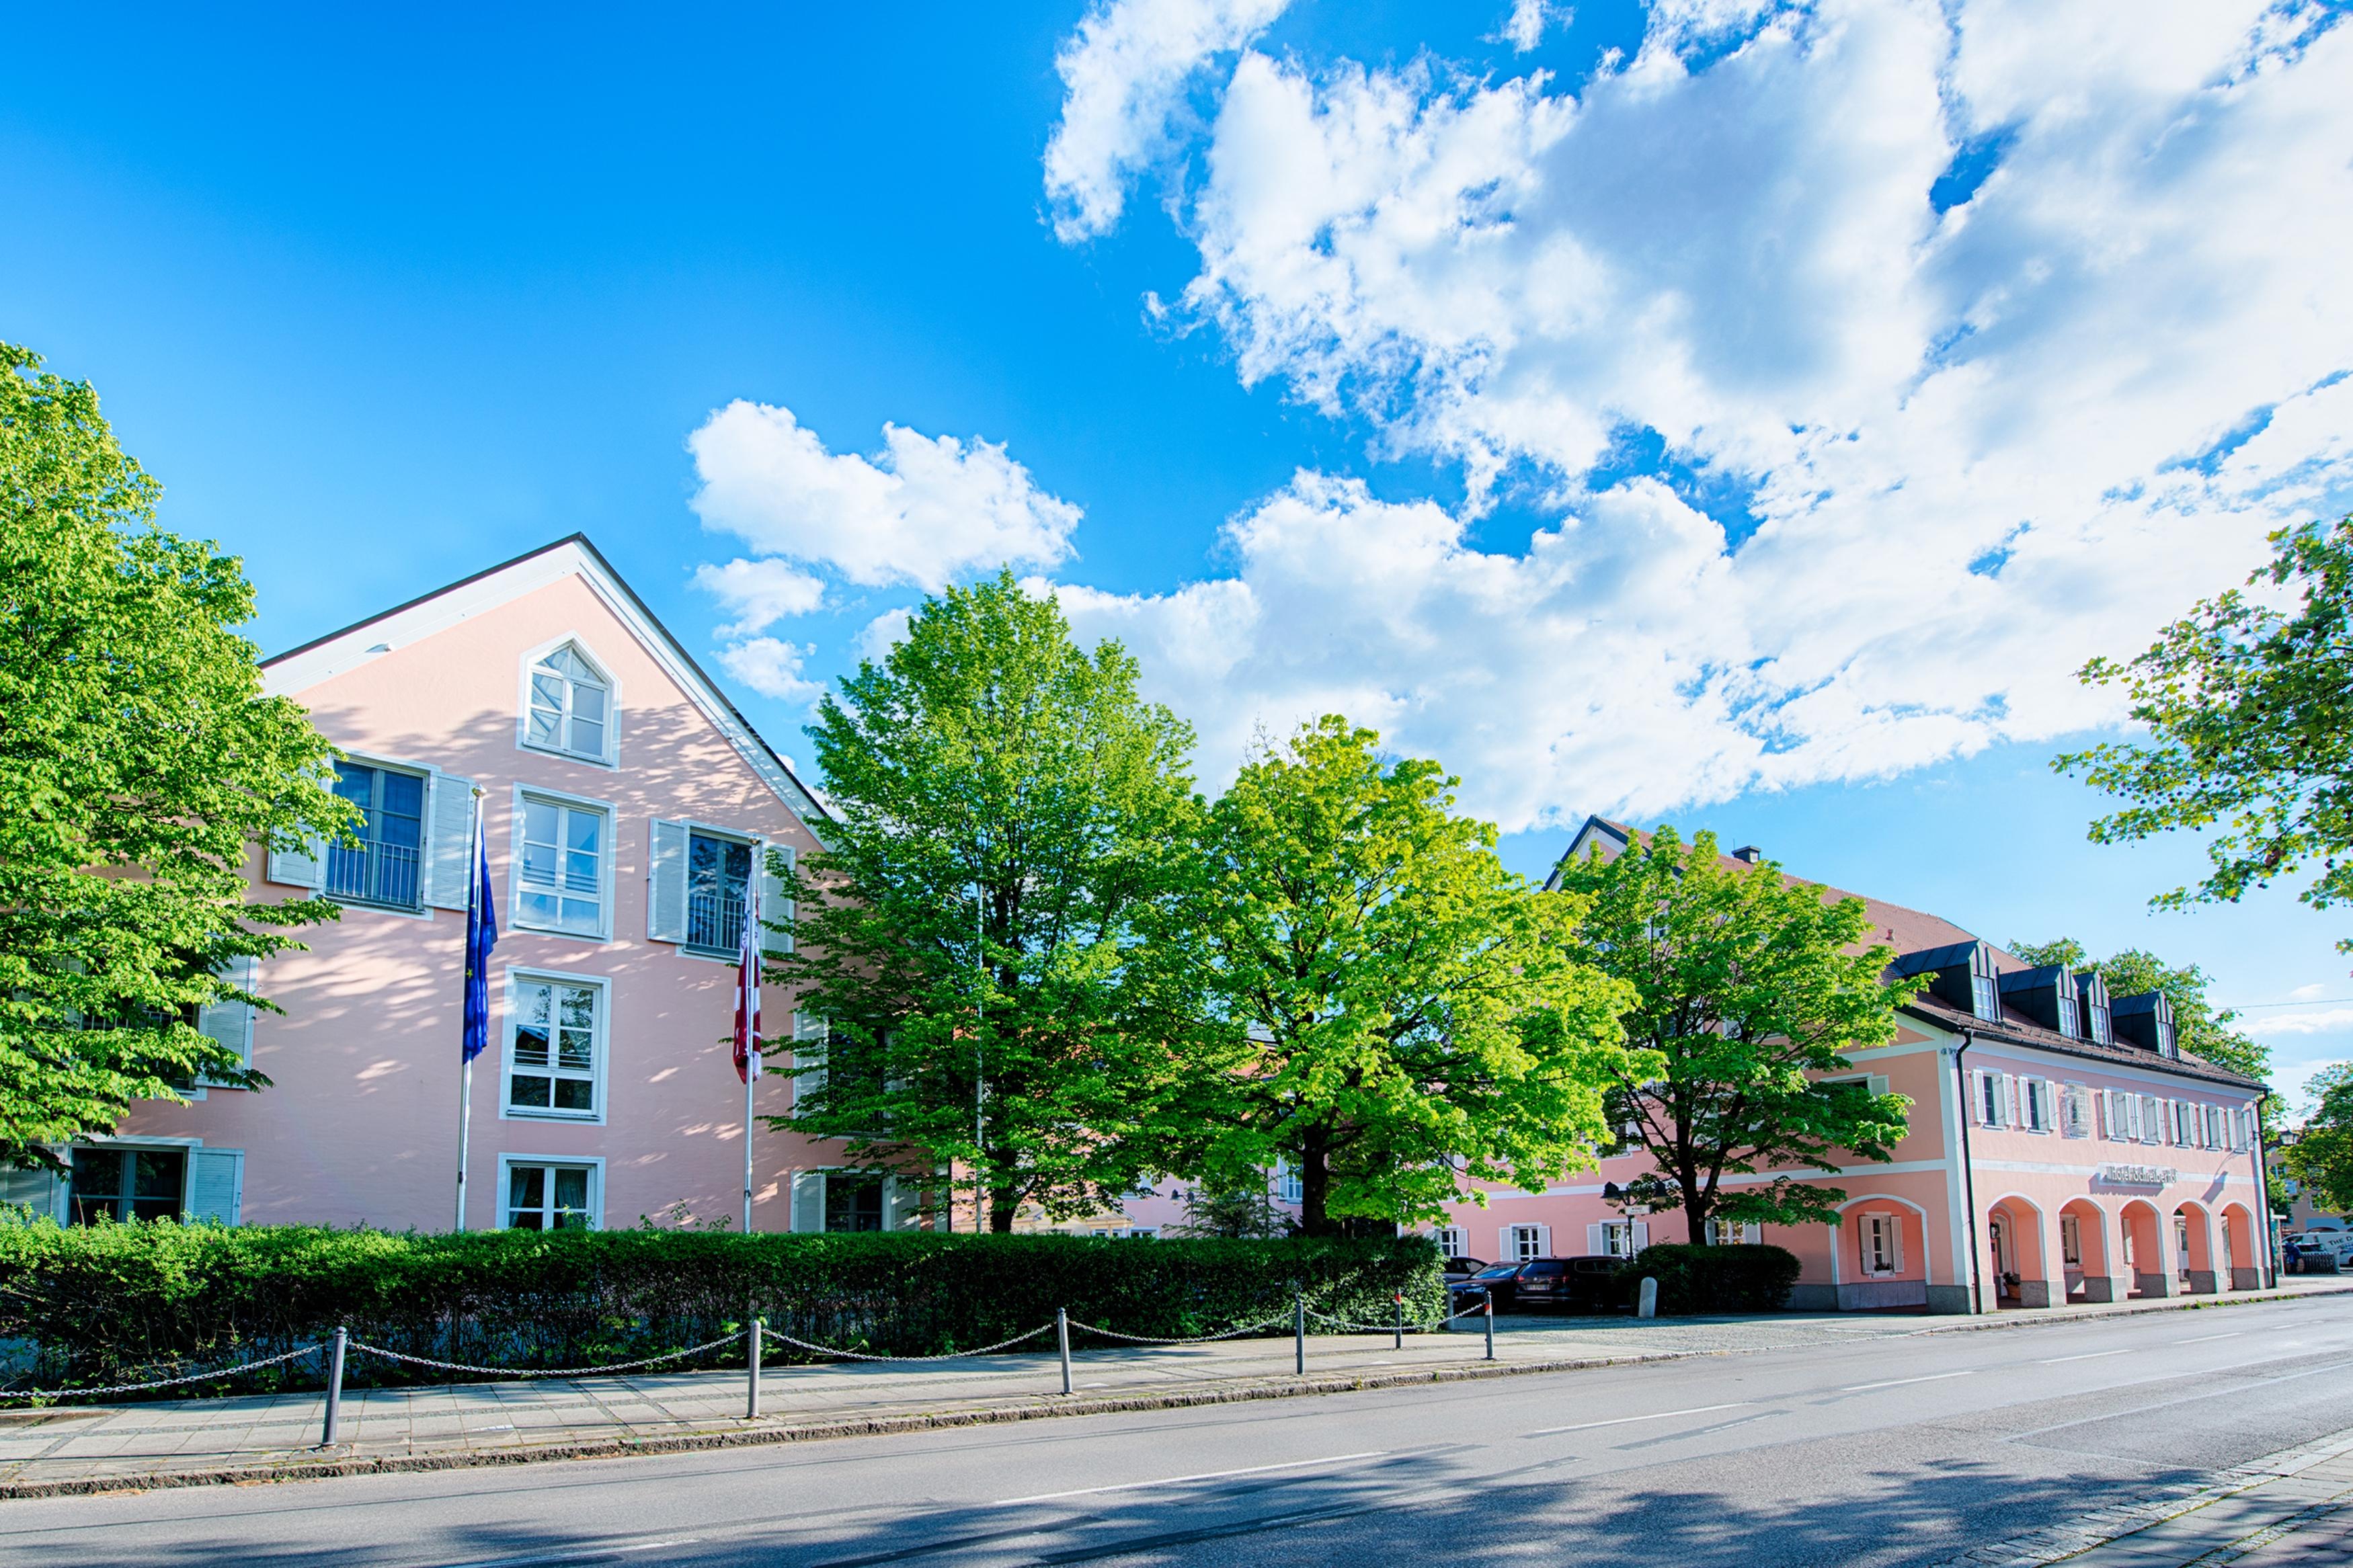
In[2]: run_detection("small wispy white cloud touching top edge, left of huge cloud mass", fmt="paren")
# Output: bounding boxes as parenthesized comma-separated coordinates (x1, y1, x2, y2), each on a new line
(1045, 0, 1289, 240)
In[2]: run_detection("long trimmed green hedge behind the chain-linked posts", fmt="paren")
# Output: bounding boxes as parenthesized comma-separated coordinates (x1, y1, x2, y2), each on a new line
(0, 1220, 1445, 1394)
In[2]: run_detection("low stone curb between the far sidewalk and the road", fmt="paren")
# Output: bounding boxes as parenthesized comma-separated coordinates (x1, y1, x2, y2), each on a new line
(0, 1281, 2353, 1500)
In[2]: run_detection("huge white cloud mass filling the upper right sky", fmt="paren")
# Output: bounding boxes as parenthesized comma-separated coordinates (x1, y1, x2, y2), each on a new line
(1040, 0, 2353, 827)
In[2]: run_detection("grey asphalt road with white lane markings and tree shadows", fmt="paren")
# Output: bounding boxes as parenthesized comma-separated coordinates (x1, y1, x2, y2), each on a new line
(18, 1298, 2353, 1568)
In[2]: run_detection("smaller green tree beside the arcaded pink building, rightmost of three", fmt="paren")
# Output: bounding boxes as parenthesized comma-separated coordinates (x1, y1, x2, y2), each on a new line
(1560, 827, 1915, 1241)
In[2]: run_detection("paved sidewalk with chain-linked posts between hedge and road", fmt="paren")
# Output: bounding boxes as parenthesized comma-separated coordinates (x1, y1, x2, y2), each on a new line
(0, 1279, 2353, 1497)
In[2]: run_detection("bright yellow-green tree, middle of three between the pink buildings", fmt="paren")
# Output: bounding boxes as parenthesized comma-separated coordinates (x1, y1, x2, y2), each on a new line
(1191, 717, 1626, 1234)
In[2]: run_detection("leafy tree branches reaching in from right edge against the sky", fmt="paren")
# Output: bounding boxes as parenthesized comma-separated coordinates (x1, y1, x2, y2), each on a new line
(2052, 518, 2353, 952)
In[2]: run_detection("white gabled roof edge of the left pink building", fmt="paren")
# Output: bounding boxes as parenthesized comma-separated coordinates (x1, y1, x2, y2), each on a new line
(262, 534, 833, 841)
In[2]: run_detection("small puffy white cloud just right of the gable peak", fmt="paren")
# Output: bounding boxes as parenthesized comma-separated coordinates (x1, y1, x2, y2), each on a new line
(687, 400, 1078, 590)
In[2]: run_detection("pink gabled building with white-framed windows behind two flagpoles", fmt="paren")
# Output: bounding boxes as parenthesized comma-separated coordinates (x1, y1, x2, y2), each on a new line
(30, 536, 920, 1229)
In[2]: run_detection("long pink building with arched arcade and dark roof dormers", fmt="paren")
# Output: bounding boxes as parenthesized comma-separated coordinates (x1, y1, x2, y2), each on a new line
(1440, 818, 2271, 1312)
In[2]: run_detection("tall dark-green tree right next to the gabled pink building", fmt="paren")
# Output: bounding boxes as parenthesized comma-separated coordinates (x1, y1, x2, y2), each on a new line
(774, 573, 1200, 1232)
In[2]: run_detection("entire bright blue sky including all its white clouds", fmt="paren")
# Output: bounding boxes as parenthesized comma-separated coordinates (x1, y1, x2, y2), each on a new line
(0, 0, 2353, 1104)
